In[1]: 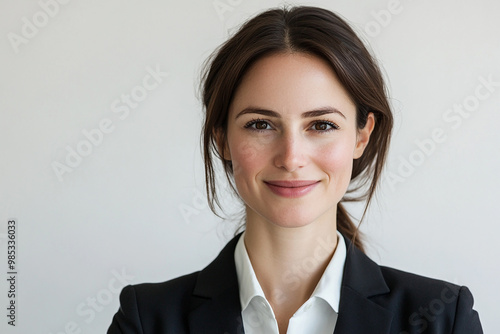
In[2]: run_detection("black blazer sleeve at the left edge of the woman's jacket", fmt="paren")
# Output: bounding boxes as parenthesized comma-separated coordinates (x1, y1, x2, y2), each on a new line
(107, 285, 144, 334)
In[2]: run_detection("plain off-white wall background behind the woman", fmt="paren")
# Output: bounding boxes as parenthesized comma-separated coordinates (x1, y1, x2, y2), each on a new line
(0, 0, 500, 334)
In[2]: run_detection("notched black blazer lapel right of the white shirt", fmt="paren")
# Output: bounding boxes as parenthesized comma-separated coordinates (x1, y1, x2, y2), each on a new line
(334, 238, 393, 334)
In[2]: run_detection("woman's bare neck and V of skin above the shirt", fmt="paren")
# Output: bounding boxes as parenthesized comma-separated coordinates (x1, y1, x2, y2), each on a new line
(245, 210, 337, 323)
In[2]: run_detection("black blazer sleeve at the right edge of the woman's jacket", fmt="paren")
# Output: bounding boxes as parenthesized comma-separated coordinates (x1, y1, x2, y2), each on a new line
(452, 286, 483, 334)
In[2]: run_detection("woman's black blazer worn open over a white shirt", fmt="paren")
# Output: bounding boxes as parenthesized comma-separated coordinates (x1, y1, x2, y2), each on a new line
(108, 234, 483, 334)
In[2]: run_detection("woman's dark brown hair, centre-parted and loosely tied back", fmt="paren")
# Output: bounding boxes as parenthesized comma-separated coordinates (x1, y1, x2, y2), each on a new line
(201, 6, 393, 250)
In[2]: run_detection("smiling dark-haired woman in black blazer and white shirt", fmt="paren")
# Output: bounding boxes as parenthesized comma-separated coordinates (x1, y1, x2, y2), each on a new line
(108, 7, 482, 334)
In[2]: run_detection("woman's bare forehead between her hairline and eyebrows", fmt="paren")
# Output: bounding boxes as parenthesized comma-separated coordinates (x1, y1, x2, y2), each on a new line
(229, 53, 355, 117)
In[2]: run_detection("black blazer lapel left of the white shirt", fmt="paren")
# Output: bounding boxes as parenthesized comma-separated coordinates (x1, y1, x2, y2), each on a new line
(189, 234, 244, 334)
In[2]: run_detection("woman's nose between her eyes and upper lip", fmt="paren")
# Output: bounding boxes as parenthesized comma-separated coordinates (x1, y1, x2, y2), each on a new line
(274, 133, 307, 172)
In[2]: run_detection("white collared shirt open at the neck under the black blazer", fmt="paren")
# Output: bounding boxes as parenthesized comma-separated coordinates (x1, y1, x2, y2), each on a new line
(234, 232, 346, 334)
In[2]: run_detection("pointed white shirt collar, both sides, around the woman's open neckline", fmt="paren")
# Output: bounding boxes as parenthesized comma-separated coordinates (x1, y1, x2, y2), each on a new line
(234, 231, 346, 313)
